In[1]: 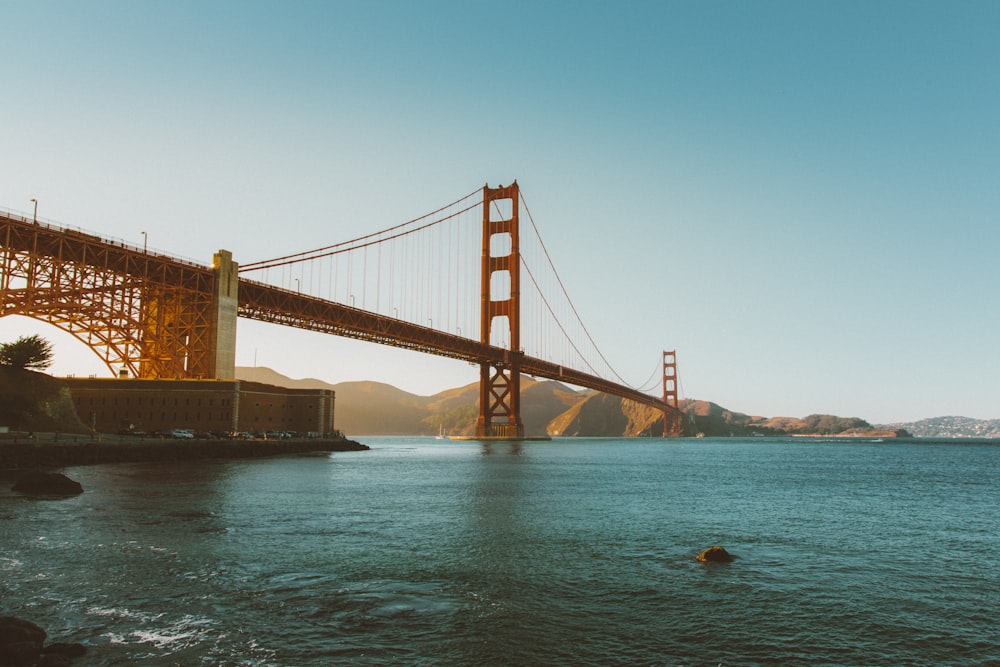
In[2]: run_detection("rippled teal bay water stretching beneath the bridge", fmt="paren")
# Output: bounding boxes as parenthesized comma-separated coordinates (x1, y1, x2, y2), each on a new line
(0, 438, 1000, 667)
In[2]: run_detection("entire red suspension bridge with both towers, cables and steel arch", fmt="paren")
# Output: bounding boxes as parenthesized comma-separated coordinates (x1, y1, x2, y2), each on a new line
(0, 181, 681, 438)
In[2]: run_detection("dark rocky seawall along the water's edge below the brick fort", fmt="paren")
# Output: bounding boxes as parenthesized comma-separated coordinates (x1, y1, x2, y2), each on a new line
(0, 438, 369, 470)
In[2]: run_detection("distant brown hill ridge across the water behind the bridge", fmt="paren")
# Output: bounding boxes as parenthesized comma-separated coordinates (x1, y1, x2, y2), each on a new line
(236, 367, 960, 437)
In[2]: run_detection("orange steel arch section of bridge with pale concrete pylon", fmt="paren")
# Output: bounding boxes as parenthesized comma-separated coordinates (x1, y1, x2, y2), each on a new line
(0, 214, 237, 378)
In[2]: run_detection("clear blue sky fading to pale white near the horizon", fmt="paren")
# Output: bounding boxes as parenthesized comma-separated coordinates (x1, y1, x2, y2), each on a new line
(0, 0, 1000, 423)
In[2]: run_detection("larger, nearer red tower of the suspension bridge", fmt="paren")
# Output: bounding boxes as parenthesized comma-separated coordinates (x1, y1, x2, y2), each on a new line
(476, 181, 524, 438)
